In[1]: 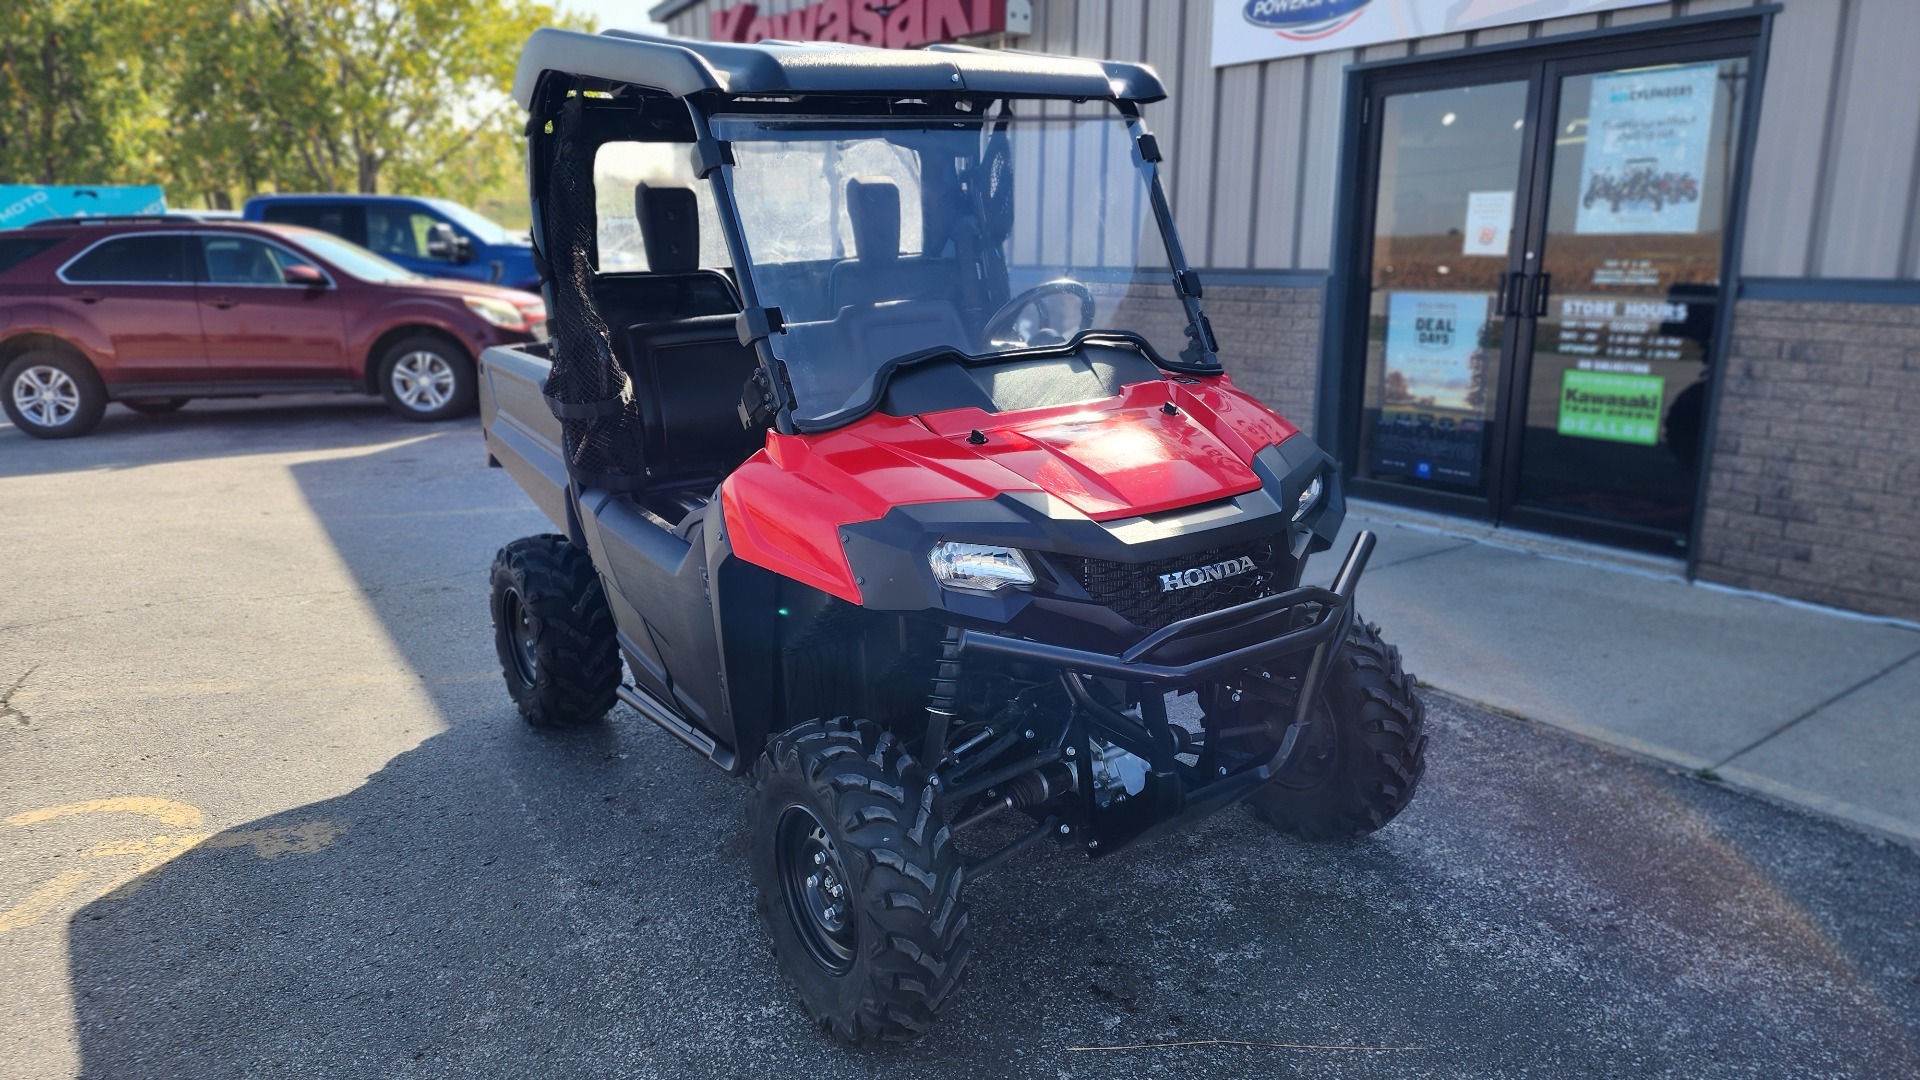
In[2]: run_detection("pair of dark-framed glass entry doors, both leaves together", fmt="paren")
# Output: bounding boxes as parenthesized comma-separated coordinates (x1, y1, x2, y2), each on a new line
(1342, 29, 1751, 553)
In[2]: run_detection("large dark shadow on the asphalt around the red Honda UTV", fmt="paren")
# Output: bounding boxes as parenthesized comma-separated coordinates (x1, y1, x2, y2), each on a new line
(69, 432, 1920, 1078)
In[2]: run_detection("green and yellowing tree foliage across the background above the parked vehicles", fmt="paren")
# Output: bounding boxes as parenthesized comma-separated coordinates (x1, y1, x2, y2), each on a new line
(0, 0, 578, 206)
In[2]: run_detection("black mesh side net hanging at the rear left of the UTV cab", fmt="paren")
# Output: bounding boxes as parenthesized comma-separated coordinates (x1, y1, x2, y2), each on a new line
(541, 98, 647, 492)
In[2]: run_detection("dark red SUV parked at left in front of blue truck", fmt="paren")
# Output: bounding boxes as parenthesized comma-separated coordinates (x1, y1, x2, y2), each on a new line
(0, 215, 547, 438)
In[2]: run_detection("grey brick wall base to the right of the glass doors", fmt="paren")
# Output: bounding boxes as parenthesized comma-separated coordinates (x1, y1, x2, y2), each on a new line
(1699, 300, 1920, 619)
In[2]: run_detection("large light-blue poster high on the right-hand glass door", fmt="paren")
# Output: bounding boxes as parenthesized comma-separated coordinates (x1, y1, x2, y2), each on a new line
(1572, 63, 1720, 233)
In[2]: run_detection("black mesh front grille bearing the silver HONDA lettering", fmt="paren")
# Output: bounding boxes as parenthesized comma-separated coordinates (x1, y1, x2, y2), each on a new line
(1054, 538, 1284, 630)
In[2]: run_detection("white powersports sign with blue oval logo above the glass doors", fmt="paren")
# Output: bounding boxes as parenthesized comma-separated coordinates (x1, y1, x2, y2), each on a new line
(1213, 0, 1659, 67)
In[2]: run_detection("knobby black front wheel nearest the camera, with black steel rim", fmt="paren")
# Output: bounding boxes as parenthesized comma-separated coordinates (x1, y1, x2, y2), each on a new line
(749, 717, 972, 1045)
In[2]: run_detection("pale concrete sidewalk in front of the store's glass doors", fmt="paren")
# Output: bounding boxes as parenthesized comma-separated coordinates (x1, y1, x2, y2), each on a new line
(1309, 502, 1920, 844)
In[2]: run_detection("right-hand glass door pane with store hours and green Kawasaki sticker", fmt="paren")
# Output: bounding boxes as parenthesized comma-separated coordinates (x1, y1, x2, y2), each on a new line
(1513, 58, 1747, 540)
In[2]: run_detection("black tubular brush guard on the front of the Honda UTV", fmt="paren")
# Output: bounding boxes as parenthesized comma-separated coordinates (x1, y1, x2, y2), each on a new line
(945, 530, 1375, 855)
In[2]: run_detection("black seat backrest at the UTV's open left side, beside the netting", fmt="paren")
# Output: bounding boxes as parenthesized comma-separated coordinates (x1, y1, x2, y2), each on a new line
(626, 315, 766, 482)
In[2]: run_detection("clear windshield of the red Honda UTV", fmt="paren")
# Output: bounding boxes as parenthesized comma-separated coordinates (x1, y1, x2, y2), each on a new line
(712, 104, 1187, 425)
